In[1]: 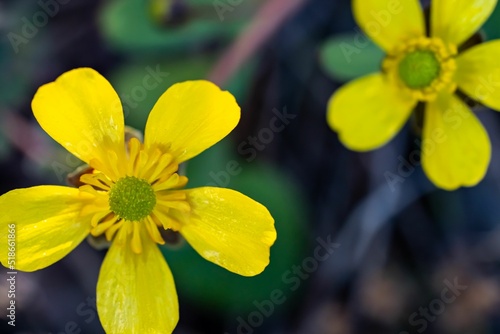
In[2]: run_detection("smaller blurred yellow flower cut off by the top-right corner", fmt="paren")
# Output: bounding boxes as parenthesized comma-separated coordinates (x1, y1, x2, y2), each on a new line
(327, 0, 500, 190)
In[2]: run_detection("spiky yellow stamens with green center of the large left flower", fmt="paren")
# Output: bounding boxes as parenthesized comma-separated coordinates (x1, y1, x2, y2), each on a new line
(79, 138, 191, 253)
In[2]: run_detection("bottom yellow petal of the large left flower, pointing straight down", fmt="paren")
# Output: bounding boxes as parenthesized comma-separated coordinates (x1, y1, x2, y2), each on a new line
(97, 222, 179, 334)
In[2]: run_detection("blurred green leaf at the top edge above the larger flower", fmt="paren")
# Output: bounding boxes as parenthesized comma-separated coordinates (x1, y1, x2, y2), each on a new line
(100, 0, 245, 55)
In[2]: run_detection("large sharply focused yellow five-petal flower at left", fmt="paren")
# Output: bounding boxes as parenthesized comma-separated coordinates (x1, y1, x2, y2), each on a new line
(0, 68, 276, 334)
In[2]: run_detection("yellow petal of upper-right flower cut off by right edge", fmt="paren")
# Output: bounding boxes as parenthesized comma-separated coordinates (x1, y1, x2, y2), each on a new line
(455, 40, 500, 111)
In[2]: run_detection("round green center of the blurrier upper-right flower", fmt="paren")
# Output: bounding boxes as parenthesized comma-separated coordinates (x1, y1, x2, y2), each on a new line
(399, 50, 441, 89)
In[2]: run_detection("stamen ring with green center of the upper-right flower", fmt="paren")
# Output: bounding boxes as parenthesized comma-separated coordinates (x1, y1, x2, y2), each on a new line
(382, 37, 457, 101)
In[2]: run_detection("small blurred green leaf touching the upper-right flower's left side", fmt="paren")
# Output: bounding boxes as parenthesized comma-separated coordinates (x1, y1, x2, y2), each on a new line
(320, 32, 384, 81)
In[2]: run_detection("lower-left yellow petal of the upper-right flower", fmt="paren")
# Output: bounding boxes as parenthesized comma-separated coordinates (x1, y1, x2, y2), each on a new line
(327, 73, 417, 151)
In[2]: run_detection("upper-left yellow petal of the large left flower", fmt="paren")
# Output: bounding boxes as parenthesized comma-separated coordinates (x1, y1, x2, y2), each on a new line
(31, 68, 124, 167)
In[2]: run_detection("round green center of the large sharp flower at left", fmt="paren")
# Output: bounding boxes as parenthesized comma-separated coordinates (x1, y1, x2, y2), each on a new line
(109, 176, 156, 221)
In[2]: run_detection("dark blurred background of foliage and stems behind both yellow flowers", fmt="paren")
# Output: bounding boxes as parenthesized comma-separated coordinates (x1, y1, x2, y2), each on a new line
(0, 0, 500, 334)
